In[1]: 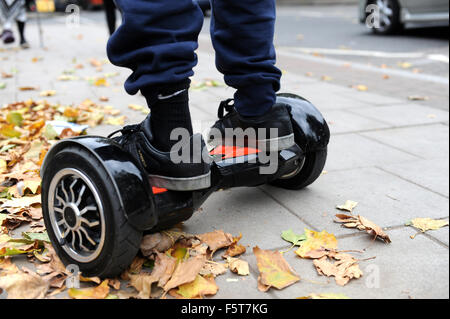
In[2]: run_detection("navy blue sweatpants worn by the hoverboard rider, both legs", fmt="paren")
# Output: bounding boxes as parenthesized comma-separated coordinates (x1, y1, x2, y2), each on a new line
(108, 0, 281, 116)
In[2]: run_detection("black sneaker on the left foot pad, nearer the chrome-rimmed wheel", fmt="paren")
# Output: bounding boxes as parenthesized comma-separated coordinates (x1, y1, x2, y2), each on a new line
(109, 115, 211, 191)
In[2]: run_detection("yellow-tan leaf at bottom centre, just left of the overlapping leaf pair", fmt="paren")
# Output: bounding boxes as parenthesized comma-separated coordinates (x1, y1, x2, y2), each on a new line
(253, 247, 300, 291)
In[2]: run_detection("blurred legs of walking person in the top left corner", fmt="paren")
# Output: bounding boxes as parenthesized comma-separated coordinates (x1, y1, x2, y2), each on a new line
(0, 0, 30, 49)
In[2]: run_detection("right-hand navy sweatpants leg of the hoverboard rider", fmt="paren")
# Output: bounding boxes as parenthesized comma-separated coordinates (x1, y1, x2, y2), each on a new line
(211, 0, 281, 116)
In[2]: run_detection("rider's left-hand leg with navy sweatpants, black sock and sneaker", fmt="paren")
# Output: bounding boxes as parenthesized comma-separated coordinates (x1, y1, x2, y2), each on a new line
(108, 0, 211, 191)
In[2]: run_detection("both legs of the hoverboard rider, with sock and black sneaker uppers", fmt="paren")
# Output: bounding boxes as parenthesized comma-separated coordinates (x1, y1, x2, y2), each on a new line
(108, 0, 293, 190)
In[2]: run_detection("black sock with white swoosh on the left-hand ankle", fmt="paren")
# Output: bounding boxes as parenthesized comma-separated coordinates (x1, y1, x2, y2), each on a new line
(142, 82, 193, 152)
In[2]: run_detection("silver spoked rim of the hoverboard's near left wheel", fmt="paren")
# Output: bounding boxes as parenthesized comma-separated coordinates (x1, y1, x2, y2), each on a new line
(48, 168, 105, 263)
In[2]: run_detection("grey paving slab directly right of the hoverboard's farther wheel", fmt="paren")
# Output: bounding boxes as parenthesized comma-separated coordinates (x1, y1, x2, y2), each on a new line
(325, 134, 419, 171)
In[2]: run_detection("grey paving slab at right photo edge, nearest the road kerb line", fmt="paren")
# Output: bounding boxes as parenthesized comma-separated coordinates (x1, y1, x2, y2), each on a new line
(351, 104, 448, 126)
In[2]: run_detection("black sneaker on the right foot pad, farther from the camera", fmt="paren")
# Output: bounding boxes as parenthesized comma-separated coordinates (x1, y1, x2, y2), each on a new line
(208, 99, 295, 152)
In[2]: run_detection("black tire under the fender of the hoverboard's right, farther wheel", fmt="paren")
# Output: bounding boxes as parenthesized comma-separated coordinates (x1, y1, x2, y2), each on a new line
(271, 149, 328, 190)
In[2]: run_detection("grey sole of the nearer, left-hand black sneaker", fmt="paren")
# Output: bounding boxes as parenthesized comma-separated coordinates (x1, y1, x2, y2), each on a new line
(148, 172, 211, 192)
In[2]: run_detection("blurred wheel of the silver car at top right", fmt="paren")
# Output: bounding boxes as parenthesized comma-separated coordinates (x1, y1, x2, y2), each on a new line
(372, 0, 402, 35)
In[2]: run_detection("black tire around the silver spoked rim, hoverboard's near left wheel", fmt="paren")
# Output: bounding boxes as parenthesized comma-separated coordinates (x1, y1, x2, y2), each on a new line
(42, 146, 142, 278)
